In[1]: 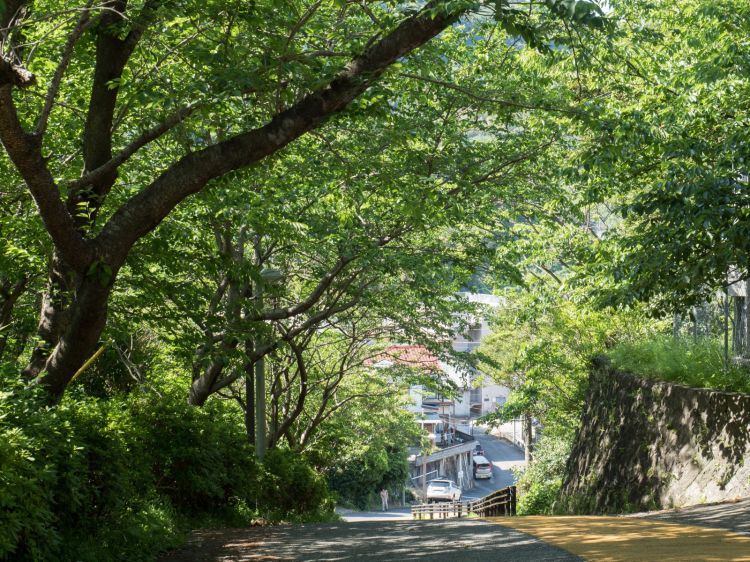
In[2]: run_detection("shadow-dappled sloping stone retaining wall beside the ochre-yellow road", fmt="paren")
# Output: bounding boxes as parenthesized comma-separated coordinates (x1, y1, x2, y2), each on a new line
(562, 359, 750, 513)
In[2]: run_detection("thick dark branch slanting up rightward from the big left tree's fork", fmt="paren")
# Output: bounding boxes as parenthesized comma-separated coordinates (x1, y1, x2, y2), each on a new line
(98, 4, 466, 263)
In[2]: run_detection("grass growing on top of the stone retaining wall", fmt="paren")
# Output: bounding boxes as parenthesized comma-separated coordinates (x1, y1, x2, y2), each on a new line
(608, 335, 750, 394)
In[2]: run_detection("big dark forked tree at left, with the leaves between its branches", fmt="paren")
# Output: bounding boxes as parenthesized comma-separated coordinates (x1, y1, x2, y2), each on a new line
(0, 0, 601, 397)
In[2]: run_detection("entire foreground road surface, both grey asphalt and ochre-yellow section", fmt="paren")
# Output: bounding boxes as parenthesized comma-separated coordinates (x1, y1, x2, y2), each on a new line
(161, 499, 750, 562)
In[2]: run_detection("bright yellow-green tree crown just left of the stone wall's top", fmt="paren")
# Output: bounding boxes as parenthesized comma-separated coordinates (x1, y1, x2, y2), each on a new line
(479, 285, 645, 438)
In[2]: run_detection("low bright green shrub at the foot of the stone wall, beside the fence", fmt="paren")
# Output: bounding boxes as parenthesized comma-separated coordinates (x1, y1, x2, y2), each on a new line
(516, 435, 571, 515)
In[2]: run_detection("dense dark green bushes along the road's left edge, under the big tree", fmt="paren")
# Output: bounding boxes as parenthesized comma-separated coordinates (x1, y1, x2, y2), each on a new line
(0, 385, 331, 561)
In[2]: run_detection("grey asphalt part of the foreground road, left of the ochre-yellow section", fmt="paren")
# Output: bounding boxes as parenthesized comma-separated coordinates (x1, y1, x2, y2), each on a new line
(160, 519, 581, 562)
